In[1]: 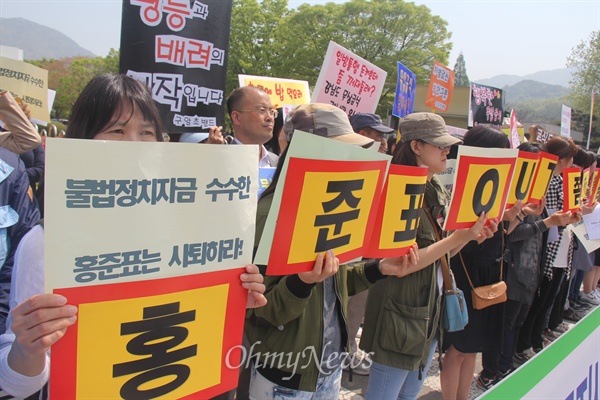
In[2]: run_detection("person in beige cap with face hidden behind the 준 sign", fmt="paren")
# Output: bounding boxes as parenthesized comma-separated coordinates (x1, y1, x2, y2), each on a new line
(245, 104, 418, 399)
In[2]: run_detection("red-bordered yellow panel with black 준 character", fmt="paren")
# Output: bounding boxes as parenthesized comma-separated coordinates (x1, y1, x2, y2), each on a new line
(267, 157, 387, 275)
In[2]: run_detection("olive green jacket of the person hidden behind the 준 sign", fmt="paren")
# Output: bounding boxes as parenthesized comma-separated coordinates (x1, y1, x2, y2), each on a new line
(245, 195, 383, 392)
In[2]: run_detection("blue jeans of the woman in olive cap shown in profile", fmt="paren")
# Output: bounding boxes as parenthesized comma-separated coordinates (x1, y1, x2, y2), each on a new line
(365, 339, 437, 400)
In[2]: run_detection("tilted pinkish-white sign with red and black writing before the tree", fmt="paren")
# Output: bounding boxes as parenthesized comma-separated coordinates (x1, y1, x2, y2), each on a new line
(311, 42, 387, 116)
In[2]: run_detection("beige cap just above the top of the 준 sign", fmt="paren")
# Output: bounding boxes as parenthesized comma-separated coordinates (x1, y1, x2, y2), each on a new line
(283, 103, 374, 148)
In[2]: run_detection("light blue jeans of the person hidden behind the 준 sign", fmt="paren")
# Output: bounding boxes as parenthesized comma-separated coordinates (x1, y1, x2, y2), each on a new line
(250, 364, 342, 400)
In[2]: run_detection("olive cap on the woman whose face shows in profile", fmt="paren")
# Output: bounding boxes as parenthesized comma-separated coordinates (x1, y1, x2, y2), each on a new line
(399, 112, 462, 146)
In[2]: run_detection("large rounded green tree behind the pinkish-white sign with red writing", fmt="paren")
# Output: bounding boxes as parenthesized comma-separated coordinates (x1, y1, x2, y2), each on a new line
(279, 0, 452, 115)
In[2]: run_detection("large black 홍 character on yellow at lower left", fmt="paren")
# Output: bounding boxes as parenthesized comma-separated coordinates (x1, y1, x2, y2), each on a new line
(113, 303, 198, 399)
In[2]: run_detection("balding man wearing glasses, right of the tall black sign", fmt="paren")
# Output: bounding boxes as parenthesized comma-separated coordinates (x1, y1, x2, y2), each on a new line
(227, 86, 279, 168)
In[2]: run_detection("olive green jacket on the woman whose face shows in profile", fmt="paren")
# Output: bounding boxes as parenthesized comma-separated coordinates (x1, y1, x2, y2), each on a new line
(360, 177, 448, 371)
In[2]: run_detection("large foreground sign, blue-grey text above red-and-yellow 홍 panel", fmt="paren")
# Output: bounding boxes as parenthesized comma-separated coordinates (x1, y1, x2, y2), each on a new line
(44, 139, 258, 399)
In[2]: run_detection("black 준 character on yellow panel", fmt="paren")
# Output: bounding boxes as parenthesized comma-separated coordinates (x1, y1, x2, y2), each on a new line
(315, 179, 364, 252)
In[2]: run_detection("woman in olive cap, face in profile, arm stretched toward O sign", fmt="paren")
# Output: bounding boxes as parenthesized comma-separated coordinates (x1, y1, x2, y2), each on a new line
(360, 113, 495, 400)
